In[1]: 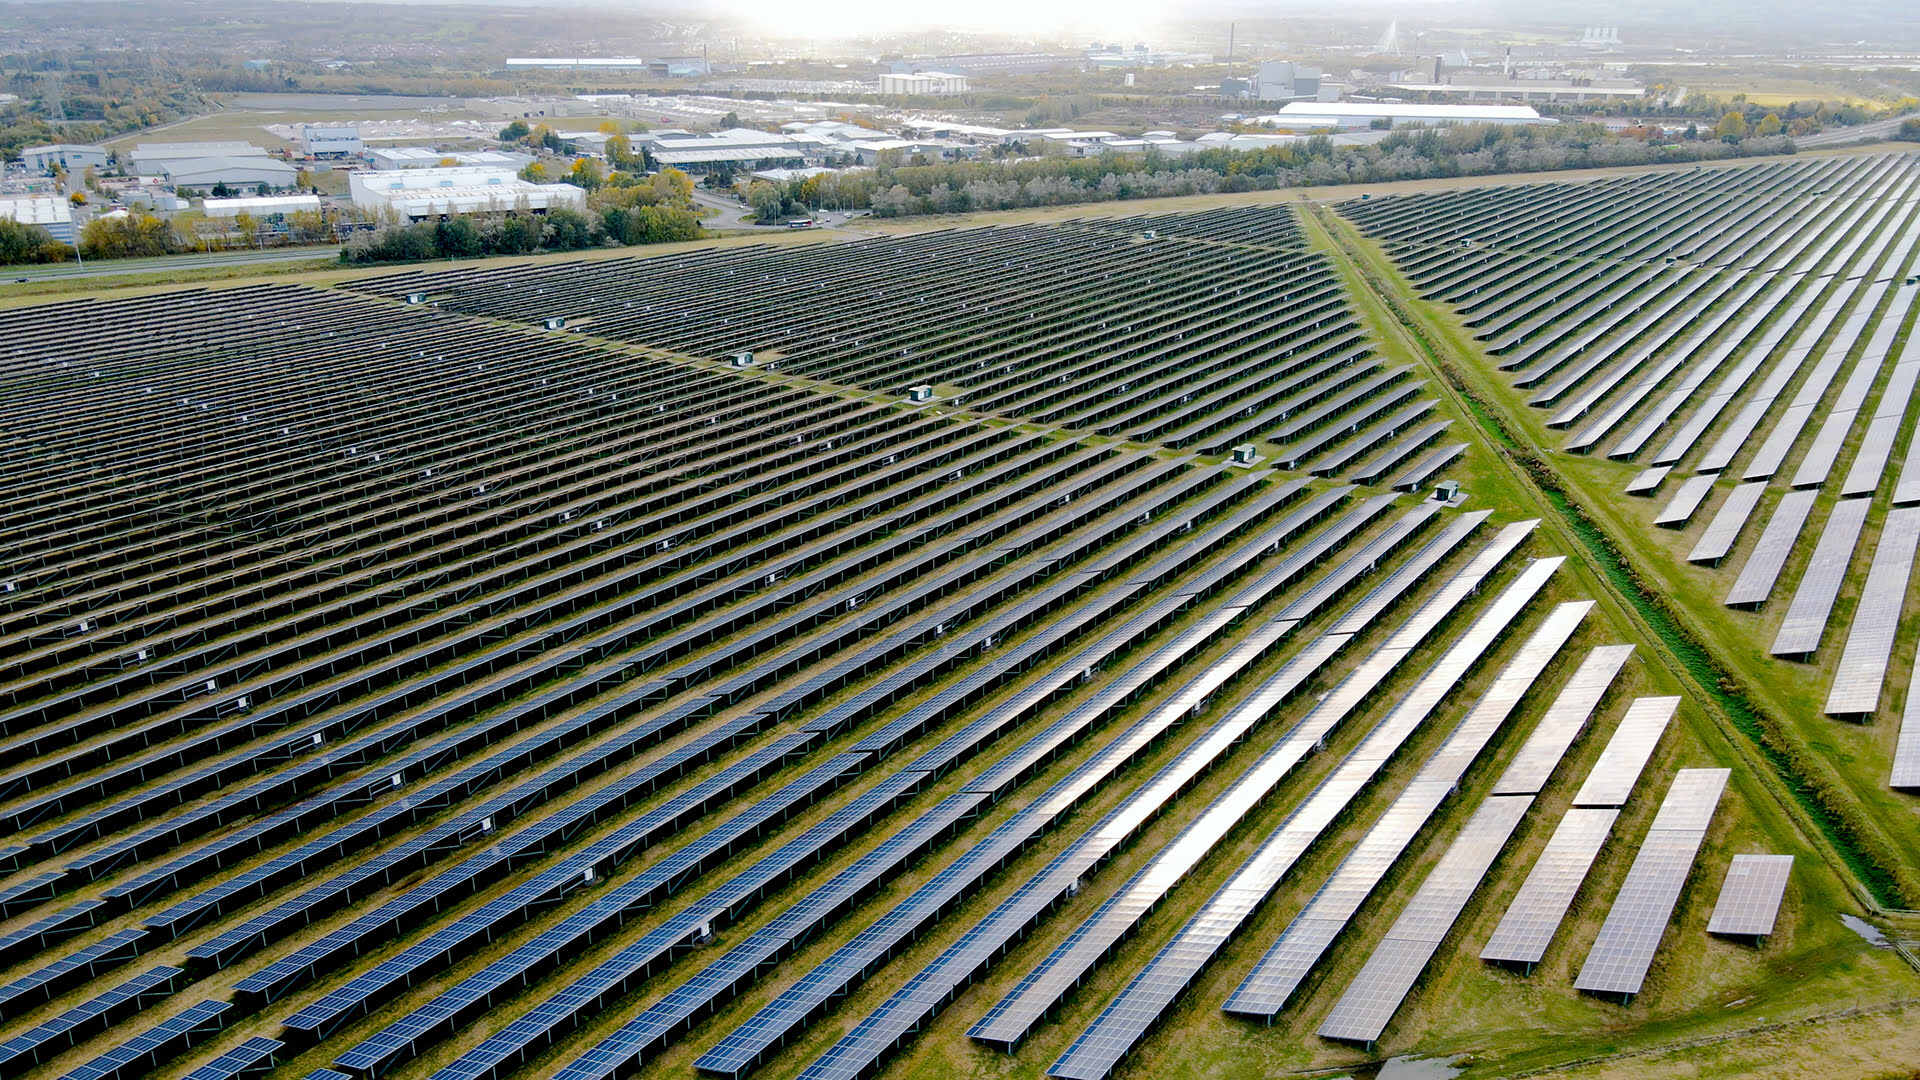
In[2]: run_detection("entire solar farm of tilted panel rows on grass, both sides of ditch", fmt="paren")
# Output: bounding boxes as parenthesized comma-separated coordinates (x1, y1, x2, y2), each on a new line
(0, 166, 1920, 1080)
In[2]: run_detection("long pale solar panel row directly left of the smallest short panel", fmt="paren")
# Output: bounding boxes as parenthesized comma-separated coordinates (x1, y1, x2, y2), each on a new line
(1574, 769, 1728, 997)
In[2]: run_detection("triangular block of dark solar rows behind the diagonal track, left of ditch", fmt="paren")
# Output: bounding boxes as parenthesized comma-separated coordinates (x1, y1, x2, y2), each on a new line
(345, 206, 1450, 488)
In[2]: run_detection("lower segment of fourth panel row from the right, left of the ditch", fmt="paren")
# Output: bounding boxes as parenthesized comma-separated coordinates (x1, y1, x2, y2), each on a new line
(1319, 796, 1534, 1043)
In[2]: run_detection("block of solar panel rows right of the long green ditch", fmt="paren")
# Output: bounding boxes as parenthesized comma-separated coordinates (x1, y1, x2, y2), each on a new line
(1340, 154, 1920, 786)
